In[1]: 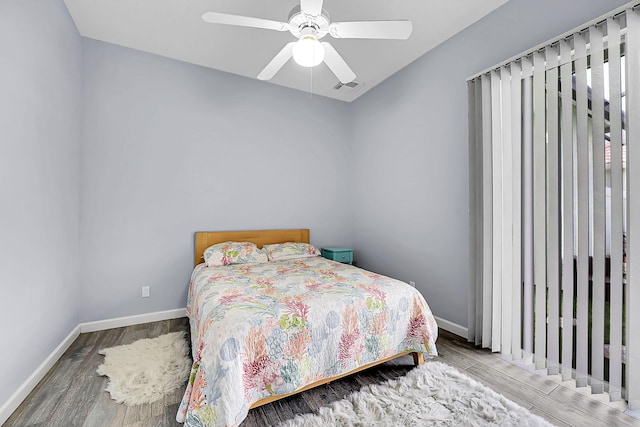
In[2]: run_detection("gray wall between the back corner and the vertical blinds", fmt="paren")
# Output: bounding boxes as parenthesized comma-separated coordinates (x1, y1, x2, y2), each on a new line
(353, 0, 626, 326)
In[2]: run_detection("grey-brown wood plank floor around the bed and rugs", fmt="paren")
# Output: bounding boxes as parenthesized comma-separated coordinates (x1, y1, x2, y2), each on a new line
(4, 318, 640, 427)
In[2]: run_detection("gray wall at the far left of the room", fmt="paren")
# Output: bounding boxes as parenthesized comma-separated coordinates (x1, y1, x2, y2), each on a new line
(0, 0, 82, 405)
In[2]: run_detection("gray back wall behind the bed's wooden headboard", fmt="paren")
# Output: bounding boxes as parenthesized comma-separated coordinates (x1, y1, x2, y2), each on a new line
(80, 40, 351, 322)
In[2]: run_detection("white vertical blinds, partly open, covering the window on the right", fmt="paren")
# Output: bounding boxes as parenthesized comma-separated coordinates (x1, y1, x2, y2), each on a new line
(468, 6, 640, 409)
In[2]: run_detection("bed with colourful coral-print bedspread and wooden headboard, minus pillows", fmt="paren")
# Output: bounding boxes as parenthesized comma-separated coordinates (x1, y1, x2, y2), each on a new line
(176, 229, 437, 427)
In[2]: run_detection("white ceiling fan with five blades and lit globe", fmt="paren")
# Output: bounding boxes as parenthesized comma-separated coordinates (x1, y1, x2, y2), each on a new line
(202, 0, 413, 83)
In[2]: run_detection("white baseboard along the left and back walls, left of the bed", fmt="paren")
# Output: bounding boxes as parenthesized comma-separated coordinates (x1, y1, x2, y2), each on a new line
(0, 308, 187, 425)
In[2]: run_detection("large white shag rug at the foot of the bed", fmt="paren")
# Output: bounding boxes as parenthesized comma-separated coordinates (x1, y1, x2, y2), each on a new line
(279, 362, 552, 427)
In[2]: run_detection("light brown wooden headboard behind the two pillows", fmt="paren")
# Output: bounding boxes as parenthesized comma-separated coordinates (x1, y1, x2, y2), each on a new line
(194, 228, 309, 265)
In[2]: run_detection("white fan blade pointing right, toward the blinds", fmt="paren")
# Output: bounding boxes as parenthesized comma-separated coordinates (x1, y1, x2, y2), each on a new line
(329, 21, 413, 40)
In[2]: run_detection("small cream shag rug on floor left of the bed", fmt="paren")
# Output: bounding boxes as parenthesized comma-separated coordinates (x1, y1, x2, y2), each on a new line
(97, 332, 191, 405)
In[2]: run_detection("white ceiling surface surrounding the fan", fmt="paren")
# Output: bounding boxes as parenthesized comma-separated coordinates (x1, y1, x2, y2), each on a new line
(65, 0, 508, 102)
